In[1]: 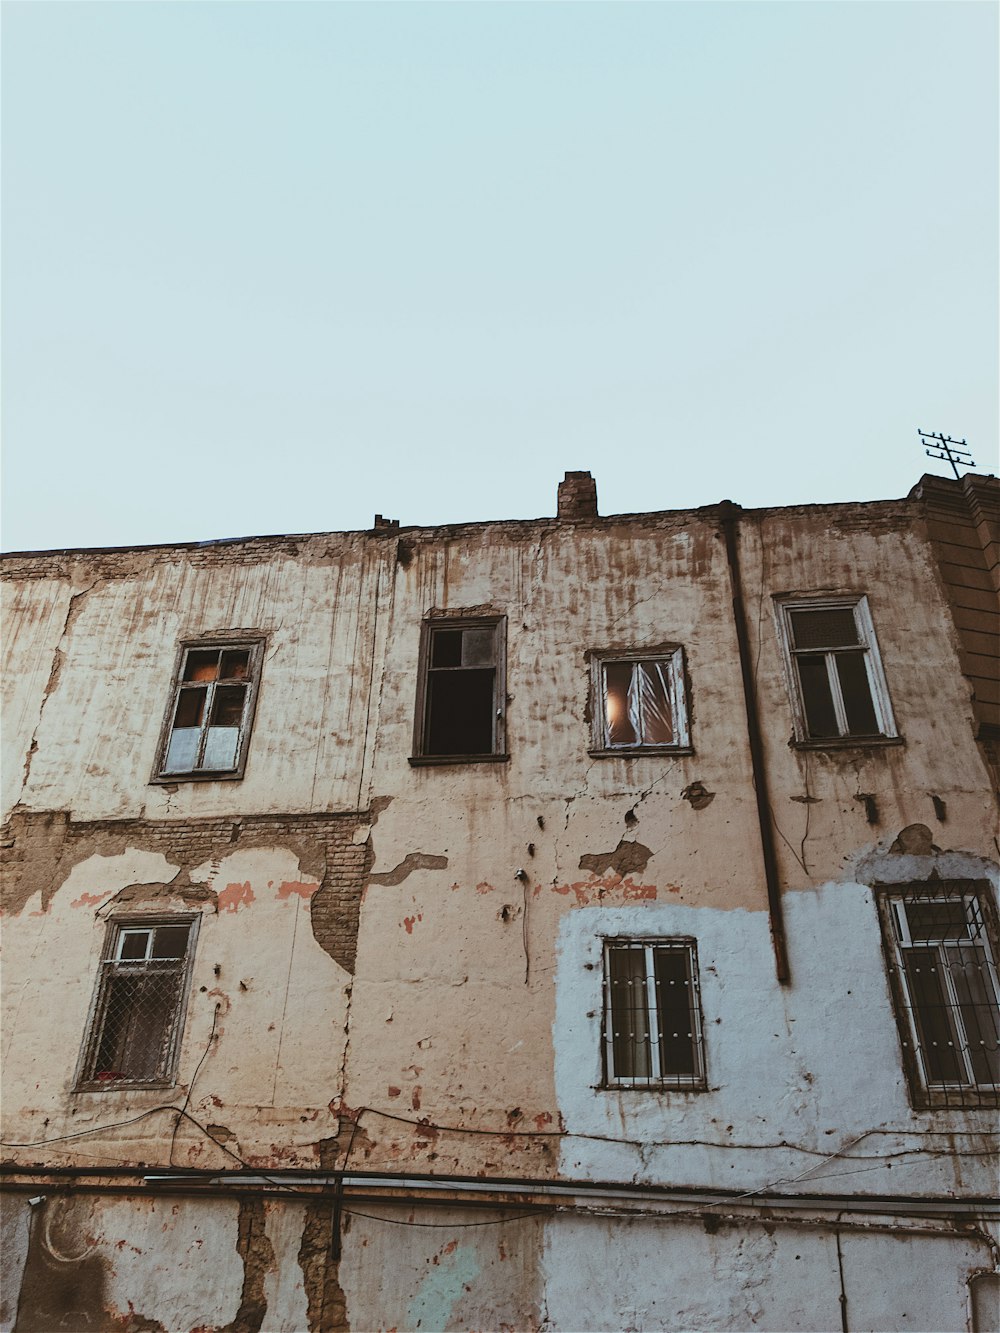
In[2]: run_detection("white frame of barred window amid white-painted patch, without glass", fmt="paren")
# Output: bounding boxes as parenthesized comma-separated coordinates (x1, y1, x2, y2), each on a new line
(601, 937, 708, 1092)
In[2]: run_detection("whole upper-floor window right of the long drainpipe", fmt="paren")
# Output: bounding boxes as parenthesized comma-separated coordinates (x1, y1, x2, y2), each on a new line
(781, 597, 896, 742)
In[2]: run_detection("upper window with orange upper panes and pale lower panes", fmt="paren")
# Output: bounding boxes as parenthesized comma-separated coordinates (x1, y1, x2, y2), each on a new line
(156, 640, 263, 781)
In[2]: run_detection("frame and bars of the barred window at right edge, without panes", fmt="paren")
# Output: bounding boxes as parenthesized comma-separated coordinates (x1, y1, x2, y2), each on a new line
(880, 881, 1000, 1106)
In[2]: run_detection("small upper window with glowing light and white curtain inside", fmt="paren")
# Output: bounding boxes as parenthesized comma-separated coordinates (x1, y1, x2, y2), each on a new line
(591, 648, 688, 753)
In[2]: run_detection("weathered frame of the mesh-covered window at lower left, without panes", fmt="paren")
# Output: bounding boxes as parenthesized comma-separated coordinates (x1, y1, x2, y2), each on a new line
(73, 913, 201, 1092)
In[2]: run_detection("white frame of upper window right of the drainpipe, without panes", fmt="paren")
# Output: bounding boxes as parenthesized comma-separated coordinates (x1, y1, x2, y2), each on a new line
(776, 593, 899, 749)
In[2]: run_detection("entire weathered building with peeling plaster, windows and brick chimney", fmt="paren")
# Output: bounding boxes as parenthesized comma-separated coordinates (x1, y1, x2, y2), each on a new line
(0, 473, 1000, 1333)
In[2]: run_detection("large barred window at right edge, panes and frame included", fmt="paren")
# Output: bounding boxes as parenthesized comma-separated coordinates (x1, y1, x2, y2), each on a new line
(880, 881, 1000, 1106)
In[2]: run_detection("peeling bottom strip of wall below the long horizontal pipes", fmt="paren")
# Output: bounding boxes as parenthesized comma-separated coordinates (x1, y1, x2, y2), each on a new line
(0, 1193, 999, 1333)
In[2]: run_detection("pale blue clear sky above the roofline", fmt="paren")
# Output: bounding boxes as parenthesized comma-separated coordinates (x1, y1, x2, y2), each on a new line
(1, 0, 1000, 551)
